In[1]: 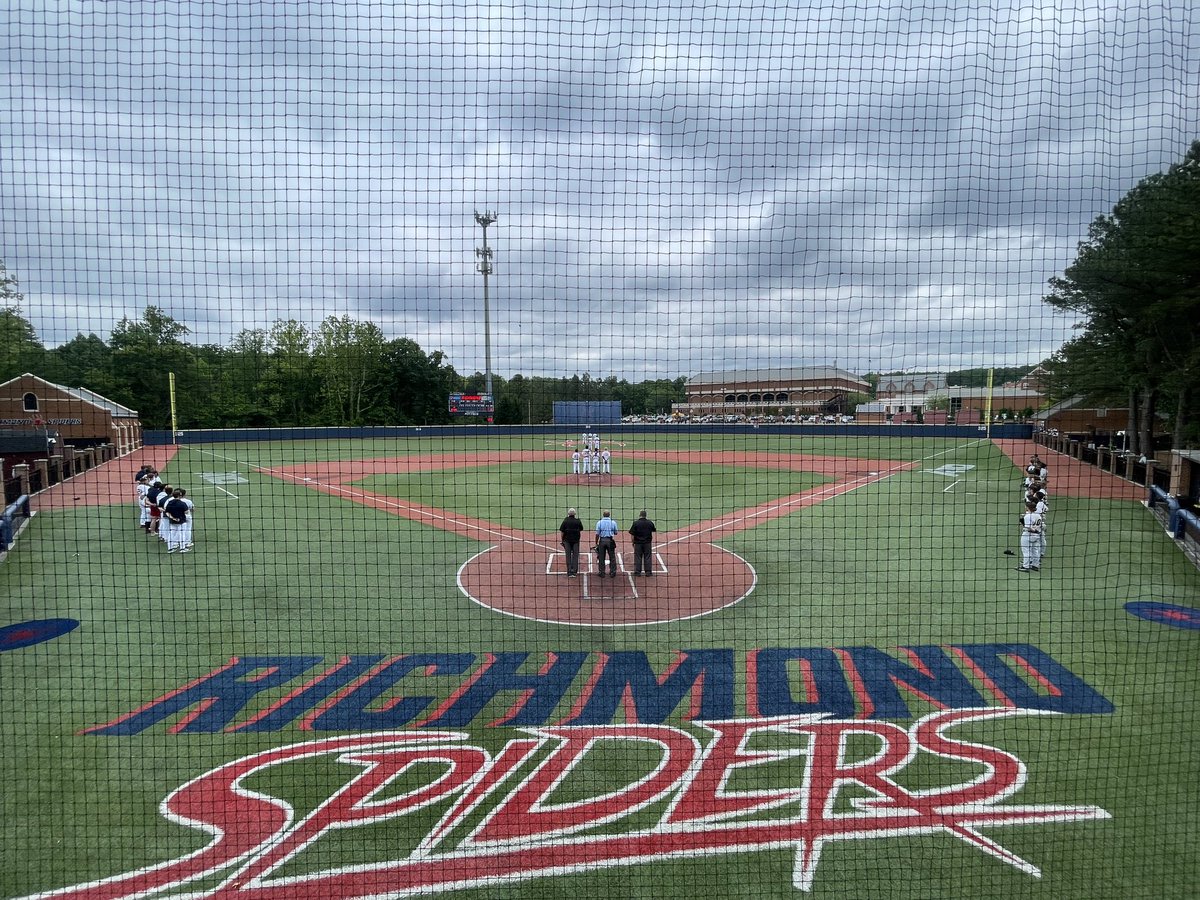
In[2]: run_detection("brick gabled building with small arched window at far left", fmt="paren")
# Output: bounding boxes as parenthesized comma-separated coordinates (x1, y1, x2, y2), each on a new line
(0, 372, 142, 456)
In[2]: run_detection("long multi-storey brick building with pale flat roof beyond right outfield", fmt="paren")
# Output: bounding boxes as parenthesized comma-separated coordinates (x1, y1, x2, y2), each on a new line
(672, 366, 871, 415)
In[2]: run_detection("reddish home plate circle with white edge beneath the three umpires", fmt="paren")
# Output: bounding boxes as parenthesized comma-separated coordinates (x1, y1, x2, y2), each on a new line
(458, 540, 755, 626)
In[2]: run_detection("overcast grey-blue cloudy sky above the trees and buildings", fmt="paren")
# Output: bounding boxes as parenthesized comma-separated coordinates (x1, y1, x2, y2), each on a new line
(0, 0, 1200, 380)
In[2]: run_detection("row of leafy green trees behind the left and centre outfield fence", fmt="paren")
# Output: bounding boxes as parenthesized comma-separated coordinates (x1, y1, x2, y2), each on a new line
(0, 286, 685, 428)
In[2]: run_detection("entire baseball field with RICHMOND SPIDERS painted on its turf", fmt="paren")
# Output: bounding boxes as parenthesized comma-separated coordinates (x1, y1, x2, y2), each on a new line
(0, 427, 1200, 900)
